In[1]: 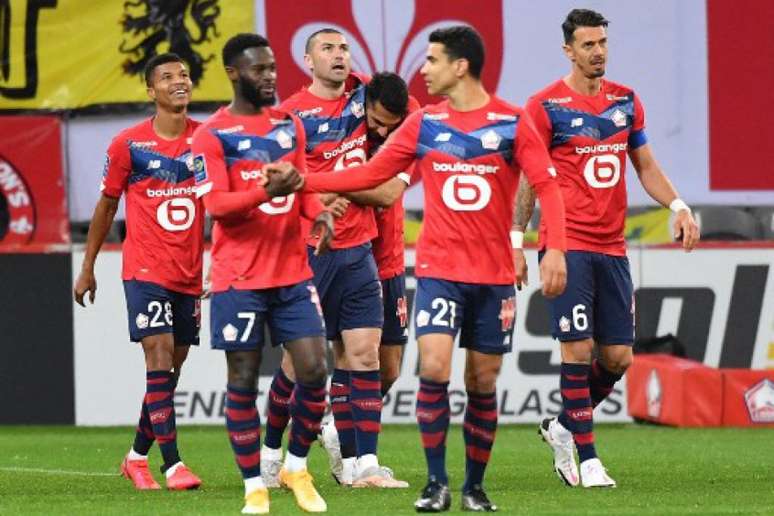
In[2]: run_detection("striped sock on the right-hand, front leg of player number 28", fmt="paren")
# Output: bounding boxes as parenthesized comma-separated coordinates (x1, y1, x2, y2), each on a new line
(145, 371, 180, 471)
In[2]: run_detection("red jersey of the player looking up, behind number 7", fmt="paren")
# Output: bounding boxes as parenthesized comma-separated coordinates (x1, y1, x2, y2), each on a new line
(280, 75, 377, 249)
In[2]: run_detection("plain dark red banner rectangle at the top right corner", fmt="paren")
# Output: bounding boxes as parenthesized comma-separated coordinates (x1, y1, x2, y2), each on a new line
(707, 0, 774, 190)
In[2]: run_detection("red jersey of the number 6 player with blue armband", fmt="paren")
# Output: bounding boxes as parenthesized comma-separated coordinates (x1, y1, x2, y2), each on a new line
(526, 79, 647, 256)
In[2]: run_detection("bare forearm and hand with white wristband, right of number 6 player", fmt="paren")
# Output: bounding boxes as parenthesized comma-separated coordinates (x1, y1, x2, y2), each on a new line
(629, 143, 699, 252)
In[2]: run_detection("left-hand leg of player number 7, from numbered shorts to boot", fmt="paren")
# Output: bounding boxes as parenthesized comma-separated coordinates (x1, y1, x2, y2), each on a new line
(210, 289, 269, 514)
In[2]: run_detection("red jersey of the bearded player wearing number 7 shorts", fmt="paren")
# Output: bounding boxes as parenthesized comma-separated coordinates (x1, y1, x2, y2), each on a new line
(193, 107, 322, 292)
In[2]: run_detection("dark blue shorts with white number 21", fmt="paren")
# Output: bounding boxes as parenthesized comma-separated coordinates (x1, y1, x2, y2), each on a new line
(414, 278, 516, 355)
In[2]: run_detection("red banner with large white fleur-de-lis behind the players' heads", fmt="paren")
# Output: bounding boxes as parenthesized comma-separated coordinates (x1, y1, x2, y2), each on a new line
(266, 0, 503, 104)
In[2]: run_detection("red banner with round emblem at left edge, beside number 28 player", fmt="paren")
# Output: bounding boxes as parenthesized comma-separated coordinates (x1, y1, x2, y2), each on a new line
(0, 116, 70, 252)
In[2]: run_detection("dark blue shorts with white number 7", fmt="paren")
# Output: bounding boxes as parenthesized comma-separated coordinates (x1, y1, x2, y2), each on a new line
(210, 280, 325, 351)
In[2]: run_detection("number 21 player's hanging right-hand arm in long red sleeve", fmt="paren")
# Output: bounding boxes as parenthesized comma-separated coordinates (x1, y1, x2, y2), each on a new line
(516, 112, 567, 297)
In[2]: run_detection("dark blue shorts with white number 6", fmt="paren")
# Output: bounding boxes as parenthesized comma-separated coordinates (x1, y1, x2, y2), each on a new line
(540, 251, 634, 345)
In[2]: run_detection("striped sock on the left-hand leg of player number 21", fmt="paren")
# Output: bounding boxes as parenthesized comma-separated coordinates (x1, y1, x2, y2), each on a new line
(417, 378, 451, 485)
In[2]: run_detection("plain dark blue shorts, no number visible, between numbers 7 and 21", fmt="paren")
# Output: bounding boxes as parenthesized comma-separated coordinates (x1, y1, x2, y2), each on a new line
(307, 242, 384, 340)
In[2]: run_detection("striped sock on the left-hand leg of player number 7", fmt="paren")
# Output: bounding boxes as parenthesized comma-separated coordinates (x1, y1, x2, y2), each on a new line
(226, 385, 261, 478)
